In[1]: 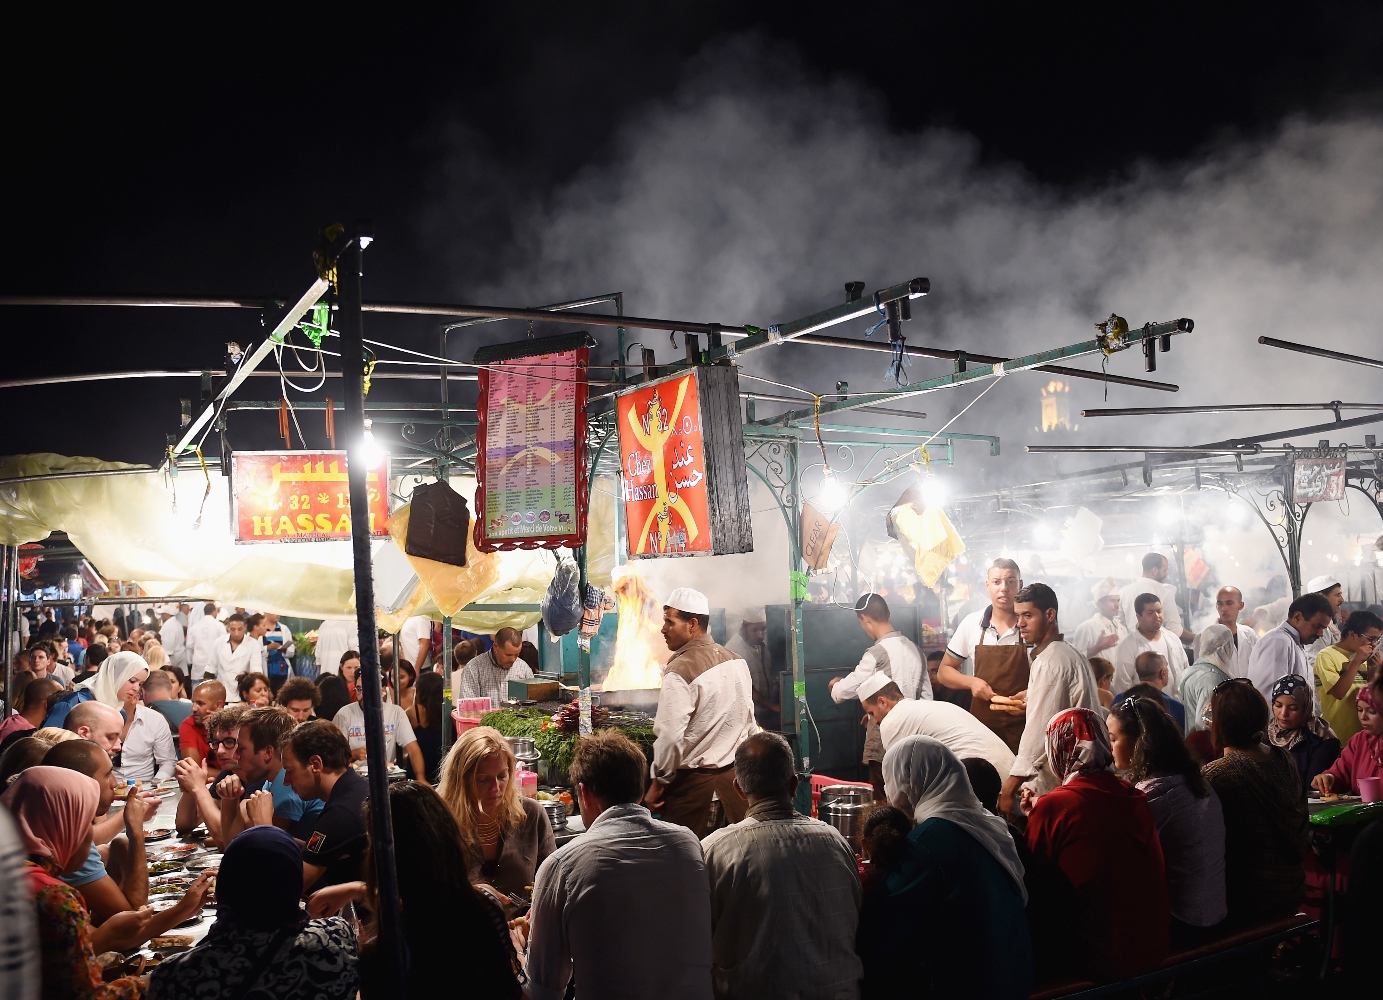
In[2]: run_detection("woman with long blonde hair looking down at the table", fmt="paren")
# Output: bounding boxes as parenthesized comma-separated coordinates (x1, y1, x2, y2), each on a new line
(437, 726, 557, 893)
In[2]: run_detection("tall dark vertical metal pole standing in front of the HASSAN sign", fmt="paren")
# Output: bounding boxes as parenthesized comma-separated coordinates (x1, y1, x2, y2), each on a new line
(336, 225, 408, 997)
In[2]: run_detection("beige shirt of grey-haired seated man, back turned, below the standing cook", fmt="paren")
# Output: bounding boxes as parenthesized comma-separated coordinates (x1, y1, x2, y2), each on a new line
(701, 802, 864, 1000)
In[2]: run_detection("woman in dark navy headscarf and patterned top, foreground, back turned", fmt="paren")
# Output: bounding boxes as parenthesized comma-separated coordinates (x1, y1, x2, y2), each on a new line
(149, 826, 360, 1000)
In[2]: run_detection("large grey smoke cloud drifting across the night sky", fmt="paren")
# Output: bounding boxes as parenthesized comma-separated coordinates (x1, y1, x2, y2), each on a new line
(428, 37, 1383, 616)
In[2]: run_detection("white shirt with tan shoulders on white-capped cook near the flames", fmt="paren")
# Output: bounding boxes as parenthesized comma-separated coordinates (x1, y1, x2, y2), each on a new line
(651, 636, 758, 781)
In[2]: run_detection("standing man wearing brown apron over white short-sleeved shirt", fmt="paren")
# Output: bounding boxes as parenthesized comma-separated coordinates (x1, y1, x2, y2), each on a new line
(936, 559, 1028, 754)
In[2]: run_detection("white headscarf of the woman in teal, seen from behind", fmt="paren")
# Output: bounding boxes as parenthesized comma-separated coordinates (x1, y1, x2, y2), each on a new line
(884, 736, 1028, 903)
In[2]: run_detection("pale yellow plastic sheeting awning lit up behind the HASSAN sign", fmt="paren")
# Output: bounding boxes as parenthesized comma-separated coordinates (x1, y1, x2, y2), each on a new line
(0, 454, 555, 632)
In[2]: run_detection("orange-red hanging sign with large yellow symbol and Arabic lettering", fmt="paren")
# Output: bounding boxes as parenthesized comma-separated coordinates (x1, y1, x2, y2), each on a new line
(617, 373, 712, 556)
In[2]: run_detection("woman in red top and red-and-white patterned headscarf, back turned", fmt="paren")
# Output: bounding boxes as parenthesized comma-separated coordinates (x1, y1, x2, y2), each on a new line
(1028, 708, 1171, 979)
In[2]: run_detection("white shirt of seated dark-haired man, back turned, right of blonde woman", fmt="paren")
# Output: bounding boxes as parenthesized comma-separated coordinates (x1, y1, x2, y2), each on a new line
(527, 802, 708, 1000)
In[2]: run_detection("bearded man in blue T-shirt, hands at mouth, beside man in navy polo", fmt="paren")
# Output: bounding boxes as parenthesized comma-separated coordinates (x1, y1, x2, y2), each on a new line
(216, 705, 322, 844)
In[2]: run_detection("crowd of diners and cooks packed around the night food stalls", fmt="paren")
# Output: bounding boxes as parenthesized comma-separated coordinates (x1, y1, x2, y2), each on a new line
(0, 560, 1383, 1000)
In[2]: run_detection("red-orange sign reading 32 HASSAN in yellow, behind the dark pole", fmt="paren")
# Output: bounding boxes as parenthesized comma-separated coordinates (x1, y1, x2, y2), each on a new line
(231, 451, 389, 542)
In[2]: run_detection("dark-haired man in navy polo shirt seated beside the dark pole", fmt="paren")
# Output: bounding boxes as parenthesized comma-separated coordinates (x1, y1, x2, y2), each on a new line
(273, 719, 369, 891)
